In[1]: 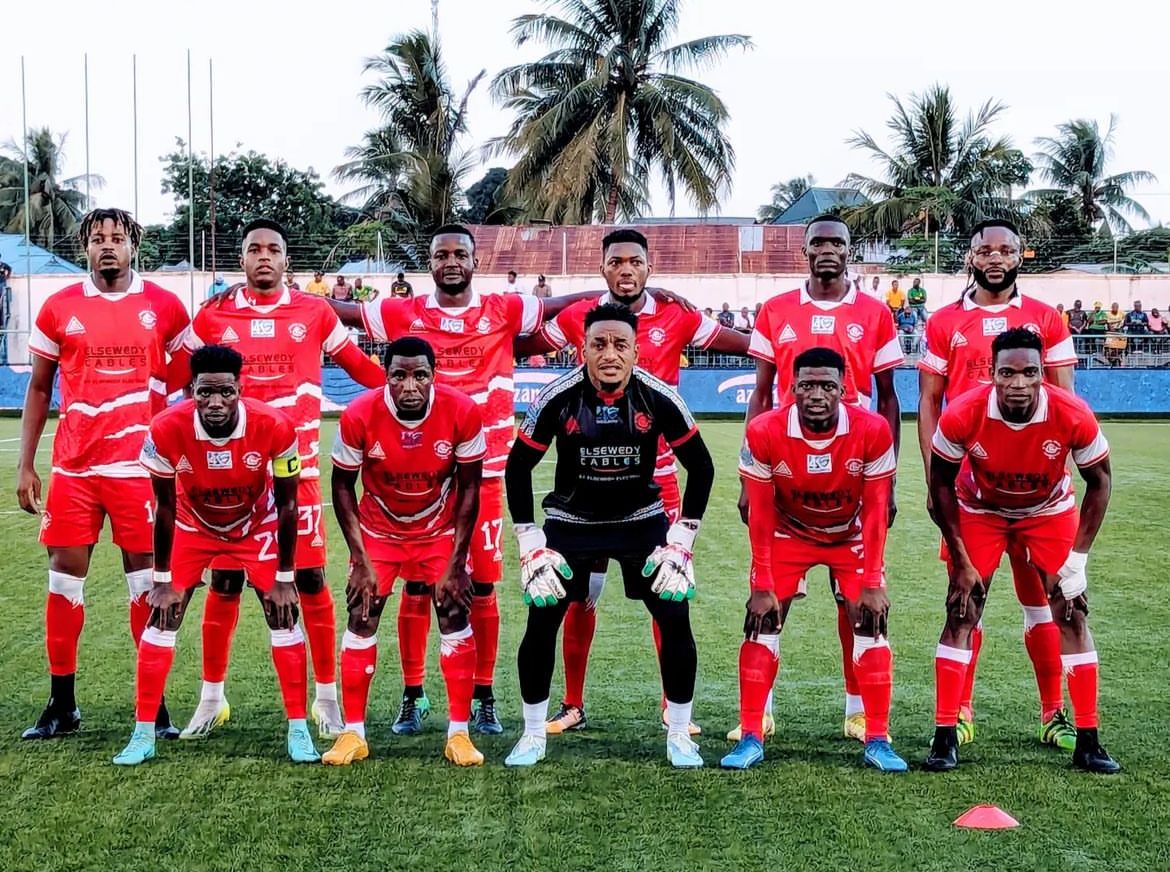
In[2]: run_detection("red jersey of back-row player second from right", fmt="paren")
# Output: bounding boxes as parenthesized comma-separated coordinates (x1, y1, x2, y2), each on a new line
(748, 288, 902, 408)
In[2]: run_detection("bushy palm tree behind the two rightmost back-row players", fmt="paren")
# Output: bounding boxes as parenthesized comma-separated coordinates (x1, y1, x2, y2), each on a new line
(845, 84, 1032, 236)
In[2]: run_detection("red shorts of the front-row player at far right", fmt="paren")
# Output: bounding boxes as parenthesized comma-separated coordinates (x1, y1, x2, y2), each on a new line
(958, 508, 1080, 587)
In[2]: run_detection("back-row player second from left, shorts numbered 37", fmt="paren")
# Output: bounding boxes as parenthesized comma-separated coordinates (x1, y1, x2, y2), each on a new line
(175, 218, 386, 739)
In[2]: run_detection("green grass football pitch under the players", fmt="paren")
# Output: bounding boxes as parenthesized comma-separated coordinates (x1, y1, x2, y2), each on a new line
(0, 420, 1170, 872)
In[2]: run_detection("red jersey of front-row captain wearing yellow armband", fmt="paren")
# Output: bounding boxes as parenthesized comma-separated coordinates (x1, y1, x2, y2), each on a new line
(140, 397, 297, 540)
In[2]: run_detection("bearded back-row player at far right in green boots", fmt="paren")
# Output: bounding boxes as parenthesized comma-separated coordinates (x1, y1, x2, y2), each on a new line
(918, 220, 1076, 750)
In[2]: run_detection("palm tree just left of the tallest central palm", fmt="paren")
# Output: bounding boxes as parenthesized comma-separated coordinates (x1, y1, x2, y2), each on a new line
(333, 30, 484, 234)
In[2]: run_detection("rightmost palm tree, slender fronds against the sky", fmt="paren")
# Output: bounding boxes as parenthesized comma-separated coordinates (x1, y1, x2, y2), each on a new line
(1027, 115, 1157, 233)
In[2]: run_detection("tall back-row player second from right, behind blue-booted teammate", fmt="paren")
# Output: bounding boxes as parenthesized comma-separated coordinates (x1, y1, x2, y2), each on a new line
(728, 215, 902, 741)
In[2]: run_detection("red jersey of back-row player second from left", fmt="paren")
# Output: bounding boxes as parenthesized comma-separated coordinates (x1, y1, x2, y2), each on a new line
(186, 288, 385, 480)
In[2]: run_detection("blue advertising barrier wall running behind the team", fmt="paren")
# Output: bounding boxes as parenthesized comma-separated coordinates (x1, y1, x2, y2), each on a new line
(0, 366, 1170, 416)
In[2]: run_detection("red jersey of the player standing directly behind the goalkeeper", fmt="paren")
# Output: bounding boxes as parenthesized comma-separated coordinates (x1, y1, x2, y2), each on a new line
(541, 294, 720, 387)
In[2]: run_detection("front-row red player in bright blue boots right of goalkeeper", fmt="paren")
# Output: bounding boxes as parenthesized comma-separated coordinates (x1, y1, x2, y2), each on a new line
(721, 346, 907, 773)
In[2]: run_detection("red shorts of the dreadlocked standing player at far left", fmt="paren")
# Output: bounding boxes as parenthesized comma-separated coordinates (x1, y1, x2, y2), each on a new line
(40, 473, 154, 554)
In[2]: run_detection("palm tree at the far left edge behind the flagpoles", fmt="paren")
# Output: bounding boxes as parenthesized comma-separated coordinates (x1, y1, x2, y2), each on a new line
(0, 128, 104, 250)
